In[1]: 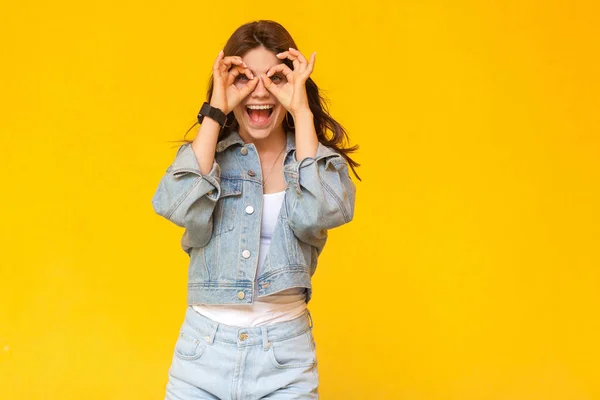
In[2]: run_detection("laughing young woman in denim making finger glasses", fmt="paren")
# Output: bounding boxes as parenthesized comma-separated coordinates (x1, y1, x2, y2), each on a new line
(152, 21, 358, 399)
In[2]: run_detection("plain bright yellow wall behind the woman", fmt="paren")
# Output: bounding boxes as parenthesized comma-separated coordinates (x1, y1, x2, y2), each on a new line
(0, 0, 600, 400)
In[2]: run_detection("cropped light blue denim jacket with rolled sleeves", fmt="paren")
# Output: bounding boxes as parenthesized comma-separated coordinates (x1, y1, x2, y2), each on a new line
(152, 132, 356, 305)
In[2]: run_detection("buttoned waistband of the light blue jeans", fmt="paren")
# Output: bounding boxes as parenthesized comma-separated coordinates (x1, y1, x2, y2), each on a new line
(185, 306, 312, 348)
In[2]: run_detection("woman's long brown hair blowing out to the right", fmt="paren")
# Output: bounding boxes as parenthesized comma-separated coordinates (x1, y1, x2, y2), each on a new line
(184, 20, 361, 180)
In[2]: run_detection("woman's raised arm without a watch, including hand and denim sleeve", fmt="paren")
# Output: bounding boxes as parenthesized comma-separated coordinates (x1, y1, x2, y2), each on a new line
(261, 48, 356, 248)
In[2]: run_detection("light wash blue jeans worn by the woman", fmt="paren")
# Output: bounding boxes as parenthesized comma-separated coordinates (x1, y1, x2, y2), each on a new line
(166, 307, 319, 400)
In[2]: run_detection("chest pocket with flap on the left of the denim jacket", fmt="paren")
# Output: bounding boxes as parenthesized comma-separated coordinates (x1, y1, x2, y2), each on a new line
(213, 178, 242, 237)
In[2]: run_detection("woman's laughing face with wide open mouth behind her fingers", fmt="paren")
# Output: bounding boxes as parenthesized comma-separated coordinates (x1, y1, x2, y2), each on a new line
(233, 47, 286, 142)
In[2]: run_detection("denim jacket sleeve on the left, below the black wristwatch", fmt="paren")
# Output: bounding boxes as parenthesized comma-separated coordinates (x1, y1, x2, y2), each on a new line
(152, 143, 221, 251)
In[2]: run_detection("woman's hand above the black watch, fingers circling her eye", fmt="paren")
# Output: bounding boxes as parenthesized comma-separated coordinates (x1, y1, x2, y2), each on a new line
(210, 50, 258, 114)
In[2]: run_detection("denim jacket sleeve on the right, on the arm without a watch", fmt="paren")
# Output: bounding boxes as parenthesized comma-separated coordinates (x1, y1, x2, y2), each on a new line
(284, 143, 356, 248)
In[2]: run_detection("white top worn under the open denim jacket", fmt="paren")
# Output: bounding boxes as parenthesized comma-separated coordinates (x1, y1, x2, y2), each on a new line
(193, 192, 306, 327)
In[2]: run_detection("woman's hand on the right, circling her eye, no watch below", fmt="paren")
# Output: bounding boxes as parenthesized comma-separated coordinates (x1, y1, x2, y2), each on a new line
(261, 47, 317, 118)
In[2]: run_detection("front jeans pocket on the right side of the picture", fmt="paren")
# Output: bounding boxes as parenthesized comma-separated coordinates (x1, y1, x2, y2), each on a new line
(269, 331, 317, 368)
